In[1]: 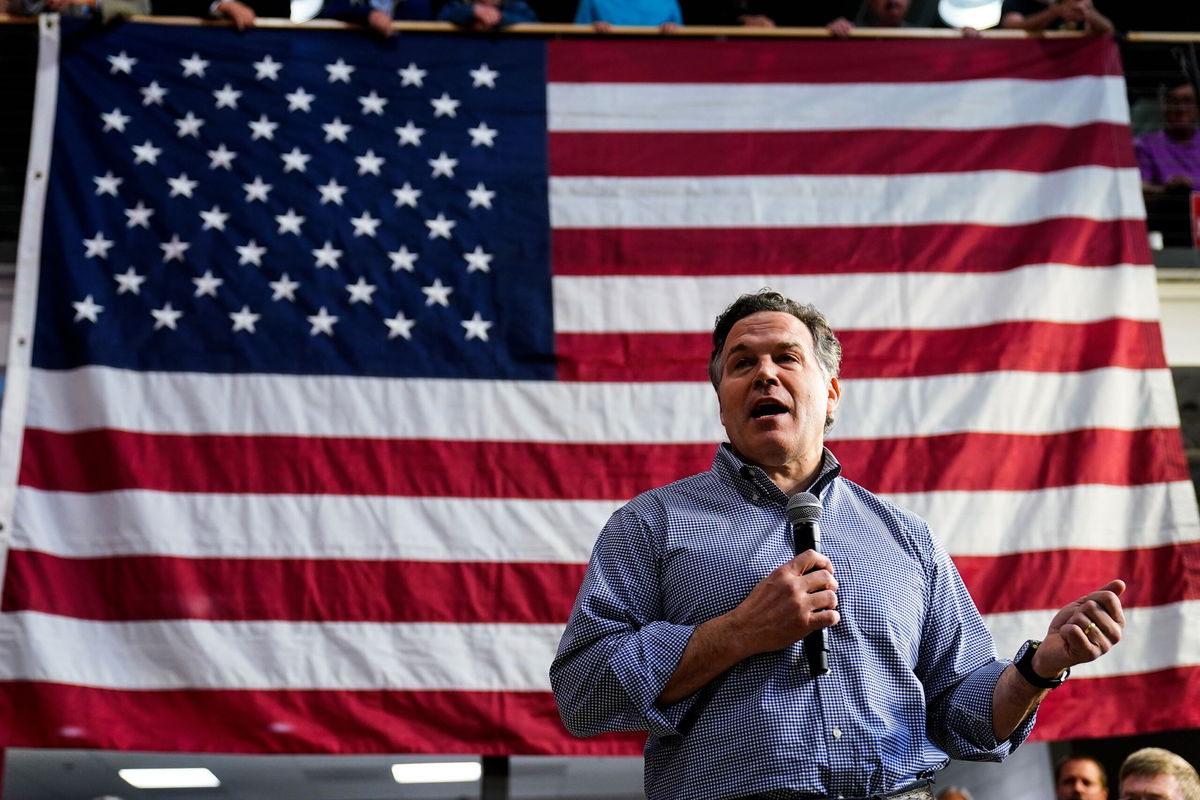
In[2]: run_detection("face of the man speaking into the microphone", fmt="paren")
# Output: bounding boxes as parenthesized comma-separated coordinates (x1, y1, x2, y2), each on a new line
(716, 311, 841, 471)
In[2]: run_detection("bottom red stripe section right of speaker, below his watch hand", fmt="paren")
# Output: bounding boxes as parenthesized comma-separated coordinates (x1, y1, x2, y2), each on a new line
(1031, 666, 1200, 748)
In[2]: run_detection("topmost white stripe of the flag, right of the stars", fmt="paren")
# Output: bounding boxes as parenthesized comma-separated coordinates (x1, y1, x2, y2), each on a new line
(546, 76, 1129, 132)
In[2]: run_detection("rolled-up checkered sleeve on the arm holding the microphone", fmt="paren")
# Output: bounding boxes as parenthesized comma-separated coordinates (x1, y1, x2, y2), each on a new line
(550, 510, 695, 738)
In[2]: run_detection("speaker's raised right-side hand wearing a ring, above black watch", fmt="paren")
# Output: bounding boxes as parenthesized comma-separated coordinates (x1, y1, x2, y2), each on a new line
(1033, 581, 1126, 678)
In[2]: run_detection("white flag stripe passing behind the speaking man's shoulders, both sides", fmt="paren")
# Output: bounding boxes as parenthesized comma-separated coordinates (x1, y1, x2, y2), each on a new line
(12, 481, 1200, 564)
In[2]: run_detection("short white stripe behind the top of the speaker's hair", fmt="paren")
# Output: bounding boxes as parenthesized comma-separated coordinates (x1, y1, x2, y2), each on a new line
(554, 264, 1158, 333)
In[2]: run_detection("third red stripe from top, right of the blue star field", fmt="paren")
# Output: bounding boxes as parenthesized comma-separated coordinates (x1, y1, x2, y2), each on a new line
(551, 218, 1152, 277)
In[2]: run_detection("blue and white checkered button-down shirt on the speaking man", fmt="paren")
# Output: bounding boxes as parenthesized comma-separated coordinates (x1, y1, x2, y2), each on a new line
(550, 445, 1033, 800)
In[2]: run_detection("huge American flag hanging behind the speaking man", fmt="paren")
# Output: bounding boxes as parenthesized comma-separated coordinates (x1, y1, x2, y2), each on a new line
(0, 19, 1200, 753)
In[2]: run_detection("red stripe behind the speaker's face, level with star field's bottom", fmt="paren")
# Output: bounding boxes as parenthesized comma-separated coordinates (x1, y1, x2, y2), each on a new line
(554, 319, 1166, 383)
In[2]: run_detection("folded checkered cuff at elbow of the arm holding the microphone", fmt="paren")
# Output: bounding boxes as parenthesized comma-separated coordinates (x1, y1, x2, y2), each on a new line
(612, 621, 696, 738)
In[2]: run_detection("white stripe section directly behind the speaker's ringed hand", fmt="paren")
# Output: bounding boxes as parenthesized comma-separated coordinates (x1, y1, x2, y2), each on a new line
(984, 597, 1200, 680)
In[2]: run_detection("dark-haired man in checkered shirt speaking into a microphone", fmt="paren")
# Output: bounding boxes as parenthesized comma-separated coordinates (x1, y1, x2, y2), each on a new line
(550, 290, 1124, 800)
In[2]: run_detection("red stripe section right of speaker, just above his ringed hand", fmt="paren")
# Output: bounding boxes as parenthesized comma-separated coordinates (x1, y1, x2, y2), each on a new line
(954, 544, 1200, 621)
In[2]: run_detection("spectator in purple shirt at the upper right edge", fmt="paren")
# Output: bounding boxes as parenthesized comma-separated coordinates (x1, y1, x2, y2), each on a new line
(1133, 82, 1200, 247)
